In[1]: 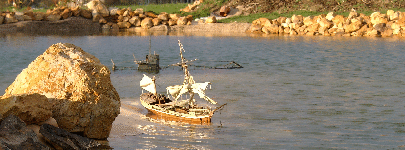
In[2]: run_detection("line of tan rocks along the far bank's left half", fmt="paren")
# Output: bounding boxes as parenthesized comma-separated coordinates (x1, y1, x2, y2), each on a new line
(0, 0, 193, 29)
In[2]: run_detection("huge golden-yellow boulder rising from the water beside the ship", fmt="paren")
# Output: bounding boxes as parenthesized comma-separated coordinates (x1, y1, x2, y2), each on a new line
(4, 43, 121, 139)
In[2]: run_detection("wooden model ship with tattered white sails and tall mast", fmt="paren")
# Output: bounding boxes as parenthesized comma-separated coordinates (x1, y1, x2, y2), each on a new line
(140, 40, 225, 123)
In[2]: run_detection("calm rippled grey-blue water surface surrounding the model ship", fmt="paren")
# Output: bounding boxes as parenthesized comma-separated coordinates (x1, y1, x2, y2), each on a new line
(0, 33, 405, 149)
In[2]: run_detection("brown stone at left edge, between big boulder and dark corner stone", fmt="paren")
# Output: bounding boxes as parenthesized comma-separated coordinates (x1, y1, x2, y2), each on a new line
(0, 93, 52, 124)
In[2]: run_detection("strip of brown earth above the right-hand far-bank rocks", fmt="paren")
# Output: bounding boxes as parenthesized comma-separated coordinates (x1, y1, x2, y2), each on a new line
(225, 0, 405, 14)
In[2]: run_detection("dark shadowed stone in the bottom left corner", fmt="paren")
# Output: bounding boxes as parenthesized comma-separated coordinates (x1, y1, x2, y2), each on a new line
(0, 115, 50, 150)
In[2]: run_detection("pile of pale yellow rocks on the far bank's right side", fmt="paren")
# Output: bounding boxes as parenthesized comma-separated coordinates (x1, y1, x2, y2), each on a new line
(248, 10, 405, 37)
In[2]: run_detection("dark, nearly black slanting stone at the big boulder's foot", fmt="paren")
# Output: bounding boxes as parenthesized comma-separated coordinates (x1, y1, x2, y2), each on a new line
(39, 124, 101, 149)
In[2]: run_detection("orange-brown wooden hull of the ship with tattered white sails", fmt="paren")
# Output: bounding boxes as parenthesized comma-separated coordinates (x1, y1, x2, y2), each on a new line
(140, 98, 212, 124)
